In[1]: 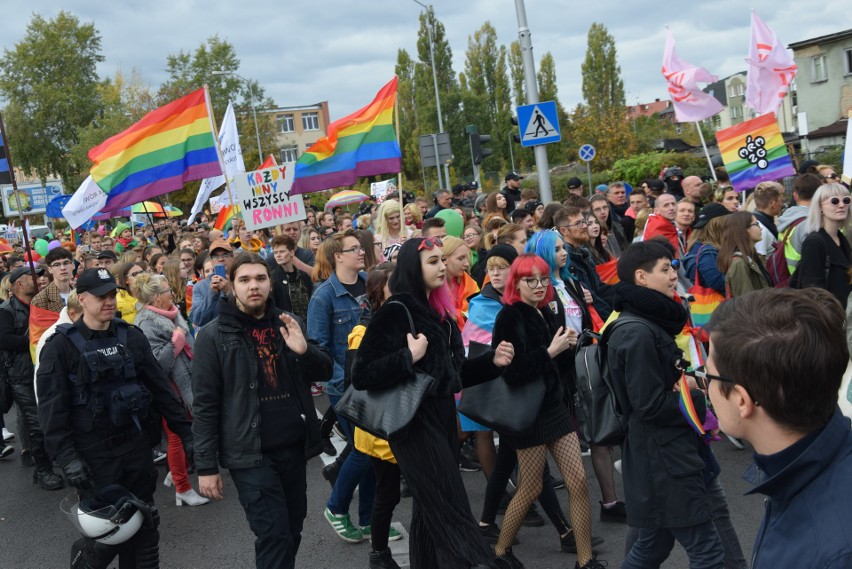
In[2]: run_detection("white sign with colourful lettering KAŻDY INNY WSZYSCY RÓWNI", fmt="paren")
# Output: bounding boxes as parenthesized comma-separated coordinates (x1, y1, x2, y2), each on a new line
(234, 162, 307, 231)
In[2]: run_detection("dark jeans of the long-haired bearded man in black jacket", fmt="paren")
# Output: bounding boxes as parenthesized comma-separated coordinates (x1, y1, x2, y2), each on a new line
(231, 445, 308, 569)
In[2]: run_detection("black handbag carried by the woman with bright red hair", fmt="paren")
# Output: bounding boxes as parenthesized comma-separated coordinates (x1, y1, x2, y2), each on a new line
(459, 342, 545, 435)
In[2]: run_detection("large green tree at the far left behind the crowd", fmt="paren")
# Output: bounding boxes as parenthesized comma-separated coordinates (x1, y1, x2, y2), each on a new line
(0, 11, 104, 188)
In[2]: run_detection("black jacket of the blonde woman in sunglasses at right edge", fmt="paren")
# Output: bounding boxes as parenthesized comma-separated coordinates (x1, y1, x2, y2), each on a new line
(790, 229, 852, 309)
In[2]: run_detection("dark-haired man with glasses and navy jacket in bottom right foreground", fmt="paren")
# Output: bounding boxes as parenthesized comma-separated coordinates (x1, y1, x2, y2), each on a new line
(704, 288, 852, 569)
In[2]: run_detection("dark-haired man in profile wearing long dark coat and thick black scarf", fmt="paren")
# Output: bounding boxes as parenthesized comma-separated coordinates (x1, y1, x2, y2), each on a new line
(606, 240, 724, 569)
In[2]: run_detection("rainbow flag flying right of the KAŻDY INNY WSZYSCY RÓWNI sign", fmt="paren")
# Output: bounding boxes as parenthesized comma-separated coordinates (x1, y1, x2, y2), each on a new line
(292, 77, 402, 194)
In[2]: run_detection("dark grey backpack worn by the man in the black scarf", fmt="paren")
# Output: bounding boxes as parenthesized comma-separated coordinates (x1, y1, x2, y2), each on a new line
(574, 316, 656, 446)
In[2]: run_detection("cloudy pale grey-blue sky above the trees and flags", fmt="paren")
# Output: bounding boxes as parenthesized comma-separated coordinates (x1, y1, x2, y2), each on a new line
(0, 0, 848, 120)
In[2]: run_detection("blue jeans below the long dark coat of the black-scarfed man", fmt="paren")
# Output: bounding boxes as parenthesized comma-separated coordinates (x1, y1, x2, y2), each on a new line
(621, 520, 725, 569)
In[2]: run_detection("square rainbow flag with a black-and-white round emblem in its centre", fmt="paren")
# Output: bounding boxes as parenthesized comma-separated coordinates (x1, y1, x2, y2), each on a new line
(716, 113, 796, 192)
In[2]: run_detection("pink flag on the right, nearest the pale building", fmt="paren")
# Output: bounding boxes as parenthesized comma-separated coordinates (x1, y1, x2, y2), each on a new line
(746, 12, 797, 115)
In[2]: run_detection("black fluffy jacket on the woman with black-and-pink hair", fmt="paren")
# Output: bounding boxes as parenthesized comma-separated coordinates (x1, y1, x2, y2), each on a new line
(352, 293, 502, 397)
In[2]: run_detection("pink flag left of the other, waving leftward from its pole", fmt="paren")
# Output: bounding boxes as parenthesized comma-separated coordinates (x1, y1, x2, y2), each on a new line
(663, 30, 722, 122)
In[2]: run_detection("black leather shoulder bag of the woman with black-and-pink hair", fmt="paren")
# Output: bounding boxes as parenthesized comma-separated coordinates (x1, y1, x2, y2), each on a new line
(334, 300, 436, 440)
